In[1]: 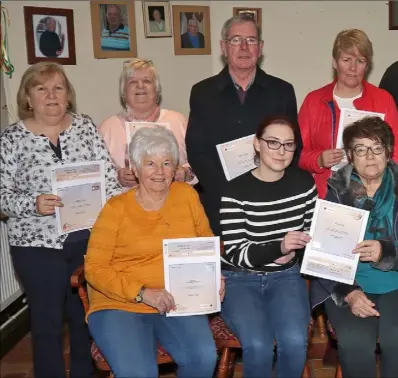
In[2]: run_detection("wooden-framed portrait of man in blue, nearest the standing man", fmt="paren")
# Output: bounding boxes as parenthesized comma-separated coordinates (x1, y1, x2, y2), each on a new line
(172, 5, 211, 55)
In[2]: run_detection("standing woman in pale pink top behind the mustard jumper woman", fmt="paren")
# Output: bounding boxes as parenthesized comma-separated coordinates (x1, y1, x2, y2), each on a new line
(99, 58, 197, 190)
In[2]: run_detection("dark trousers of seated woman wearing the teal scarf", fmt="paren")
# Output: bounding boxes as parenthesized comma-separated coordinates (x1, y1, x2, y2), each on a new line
(325, 290, 398, 378)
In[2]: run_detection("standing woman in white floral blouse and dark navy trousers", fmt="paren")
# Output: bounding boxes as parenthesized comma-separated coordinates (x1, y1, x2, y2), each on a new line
(0, 62, 121, 378)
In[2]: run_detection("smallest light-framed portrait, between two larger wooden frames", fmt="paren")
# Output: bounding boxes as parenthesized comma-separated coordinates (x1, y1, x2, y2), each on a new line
(142, 1, 172, 38)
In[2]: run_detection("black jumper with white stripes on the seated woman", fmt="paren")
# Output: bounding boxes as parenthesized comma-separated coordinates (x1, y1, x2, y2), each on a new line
(220, 167, 317, 271)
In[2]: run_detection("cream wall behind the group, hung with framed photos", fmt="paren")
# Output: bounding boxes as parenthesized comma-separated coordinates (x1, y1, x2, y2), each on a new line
(2, 0, 398, 126)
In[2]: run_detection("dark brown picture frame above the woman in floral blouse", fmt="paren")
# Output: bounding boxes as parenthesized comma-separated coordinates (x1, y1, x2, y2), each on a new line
(23, 6, 76, 65)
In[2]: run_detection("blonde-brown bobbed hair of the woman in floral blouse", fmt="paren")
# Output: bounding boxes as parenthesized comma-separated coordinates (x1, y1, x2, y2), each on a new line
(17, 62, 76, 120)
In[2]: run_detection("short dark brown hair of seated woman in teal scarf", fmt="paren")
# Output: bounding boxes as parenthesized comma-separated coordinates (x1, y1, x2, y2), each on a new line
(343, 117, 395, 158)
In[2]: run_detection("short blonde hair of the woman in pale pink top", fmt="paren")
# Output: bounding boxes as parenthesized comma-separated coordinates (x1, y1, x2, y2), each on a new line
(119, 58, 162, 107)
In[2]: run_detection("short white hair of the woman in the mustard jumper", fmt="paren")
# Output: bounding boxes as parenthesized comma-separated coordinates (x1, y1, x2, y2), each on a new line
(129, 126, 179, 168)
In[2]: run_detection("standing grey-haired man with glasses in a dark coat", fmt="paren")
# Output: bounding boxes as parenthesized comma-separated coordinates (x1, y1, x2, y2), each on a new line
(186, 15, 302, 235)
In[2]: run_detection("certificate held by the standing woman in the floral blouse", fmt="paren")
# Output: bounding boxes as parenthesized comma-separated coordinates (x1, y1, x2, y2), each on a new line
(51, 161, 106, 235)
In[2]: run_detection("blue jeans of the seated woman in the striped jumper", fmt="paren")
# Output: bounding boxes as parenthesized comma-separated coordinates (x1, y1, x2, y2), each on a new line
(221, 265, 310, 378)
